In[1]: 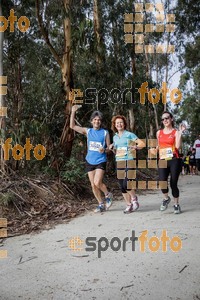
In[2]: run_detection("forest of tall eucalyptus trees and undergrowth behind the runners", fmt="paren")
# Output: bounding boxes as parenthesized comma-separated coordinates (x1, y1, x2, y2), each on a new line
(0, 0, 200, 234)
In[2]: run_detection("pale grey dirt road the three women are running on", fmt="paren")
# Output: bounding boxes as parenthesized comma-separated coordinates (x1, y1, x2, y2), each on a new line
(0, 175, 200, 300)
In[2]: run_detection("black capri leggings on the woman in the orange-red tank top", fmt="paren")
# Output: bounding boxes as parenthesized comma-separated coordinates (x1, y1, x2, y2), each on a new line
(158, 158, 181, 198)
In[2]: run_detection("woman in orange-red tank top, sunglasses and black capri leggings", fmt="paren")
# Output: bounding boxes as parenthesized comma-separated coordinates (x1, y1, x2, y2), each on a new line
(157, 111, 186, 214)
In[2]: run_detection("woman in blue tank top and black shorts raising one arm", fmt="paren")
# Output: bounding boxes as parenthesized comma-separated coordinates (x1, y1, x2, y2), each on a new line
(70, 105, 113, 212)
